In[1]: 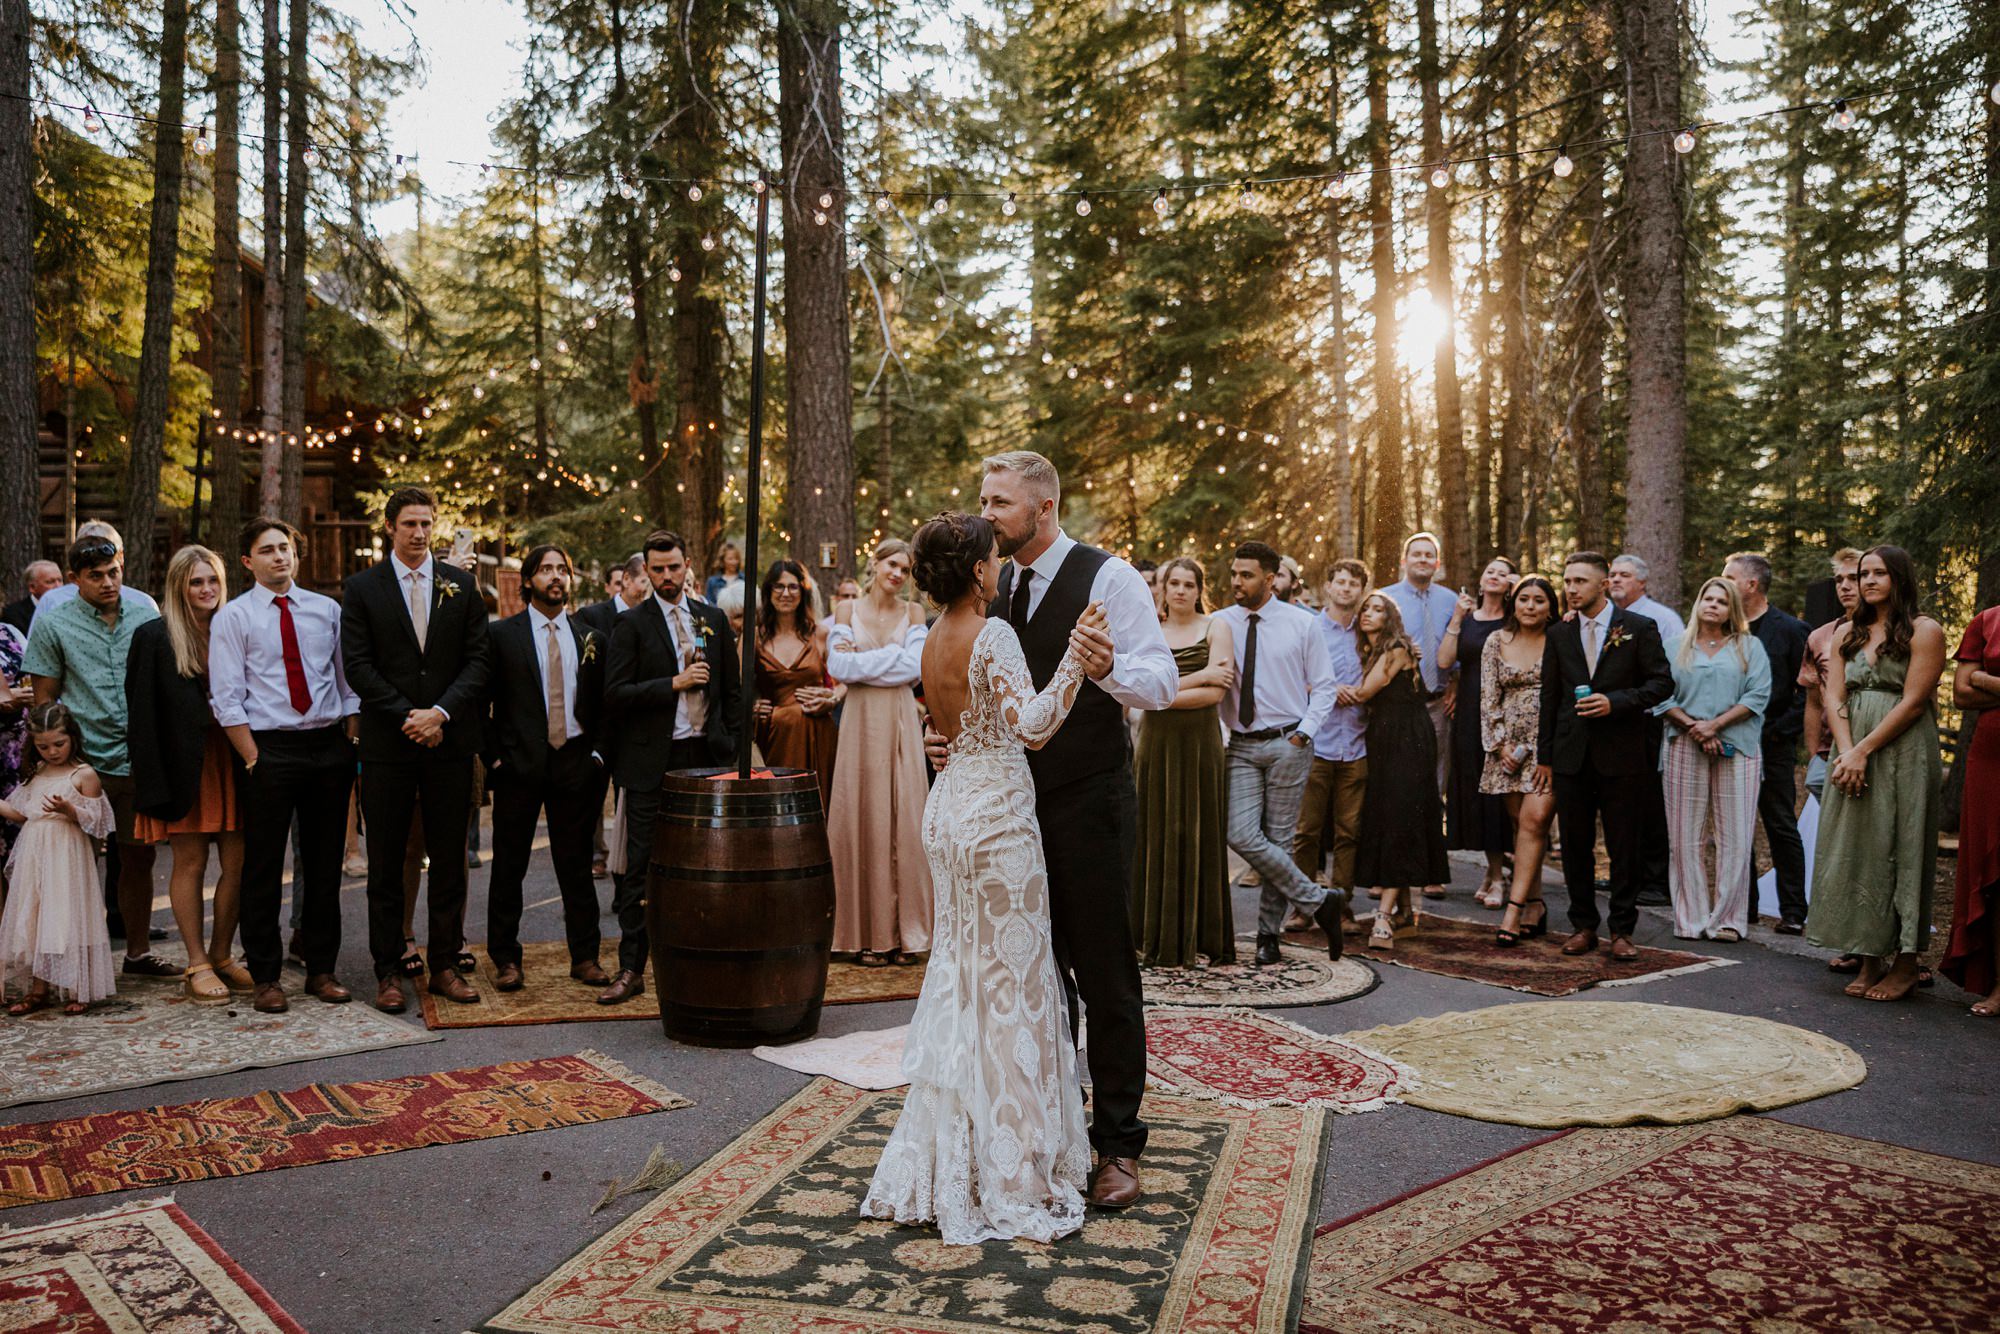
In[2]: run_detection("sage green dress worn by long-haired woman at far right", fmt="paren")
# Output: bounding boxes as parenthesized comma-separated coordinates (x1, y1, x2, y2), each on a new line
(1806, 654, 1944, 958)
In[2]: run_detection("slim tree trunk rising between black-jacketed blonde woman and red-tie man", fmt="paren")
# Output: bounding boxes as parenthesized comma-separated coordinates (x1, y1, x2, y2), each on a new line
(212, 0, 248, 576)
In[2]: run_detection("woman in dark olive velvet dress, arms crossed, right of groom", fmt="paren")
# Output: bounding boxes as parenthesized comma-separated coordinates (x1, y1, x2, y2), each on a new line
(1130, 556, 1236, 968)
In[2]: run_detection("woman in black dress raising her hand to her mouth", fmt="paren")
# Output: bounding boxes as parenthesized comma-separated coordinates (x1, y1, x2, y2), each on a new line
(1438, 556, 1520, 908)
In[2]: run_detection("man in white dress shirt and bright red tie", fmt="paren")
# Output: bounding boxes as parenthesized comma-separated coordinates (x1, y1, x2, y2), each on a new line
(208, 518, 362, 1014)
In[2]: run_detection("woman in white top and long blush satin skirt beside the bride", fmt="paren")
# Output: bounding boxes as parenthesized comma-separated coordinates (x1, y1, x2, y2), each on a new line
(826, 538, 932, 968)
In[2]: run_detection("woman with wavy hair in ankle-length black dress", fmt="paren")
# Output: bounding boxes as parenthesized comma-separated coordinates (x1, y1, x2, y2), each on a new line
(1354, 592, 1452, 950)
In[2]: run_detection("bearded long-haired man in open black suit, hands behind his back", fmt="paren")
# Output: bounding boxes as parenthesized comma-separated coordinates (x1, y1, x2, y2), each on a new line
(486, 546, 610, 992)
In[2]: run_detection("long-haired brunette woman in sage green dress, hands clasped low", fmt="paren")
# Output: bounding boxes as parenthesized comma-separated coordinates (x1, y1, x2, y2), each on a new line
(1806, 546, 1944, 1000)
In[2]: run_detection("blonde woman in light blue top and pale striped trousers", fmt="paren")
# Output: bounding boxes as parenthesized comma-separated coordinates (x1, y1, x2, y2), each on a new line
(1660, 576, 1792, 940)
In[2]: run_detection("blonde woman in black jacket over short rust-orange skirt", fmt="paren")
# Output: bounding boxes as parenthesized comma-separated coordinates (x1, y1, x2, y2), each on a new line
(126, 546, 250, 1004)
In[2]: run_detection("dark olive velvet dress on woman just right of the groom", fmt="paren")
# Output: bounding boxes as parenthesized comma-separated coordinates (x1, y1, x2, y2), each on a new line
(1130, 638, 1236, 968)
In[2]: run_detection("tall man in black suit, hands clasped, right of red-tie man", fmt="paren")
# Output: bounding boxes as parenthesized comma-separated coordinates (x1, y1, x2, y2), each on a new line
(340, 486, 488, 1014)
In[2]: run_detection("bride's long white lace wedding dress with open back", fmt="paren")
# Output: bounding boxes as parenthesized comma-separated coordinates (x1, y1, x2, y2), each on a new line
(862, 620, 1112, 1246)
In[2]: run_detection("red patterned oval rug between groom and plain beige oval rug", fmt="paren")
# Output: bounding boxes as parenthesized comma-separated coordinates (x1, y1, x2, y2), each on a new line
(1146, 1008, 1412, 1112)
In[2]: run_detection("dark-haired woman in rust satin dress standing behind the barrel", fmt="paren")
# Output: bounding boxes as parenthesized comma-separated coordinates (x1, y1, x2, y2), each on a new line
(756, 560, 846, 810)
